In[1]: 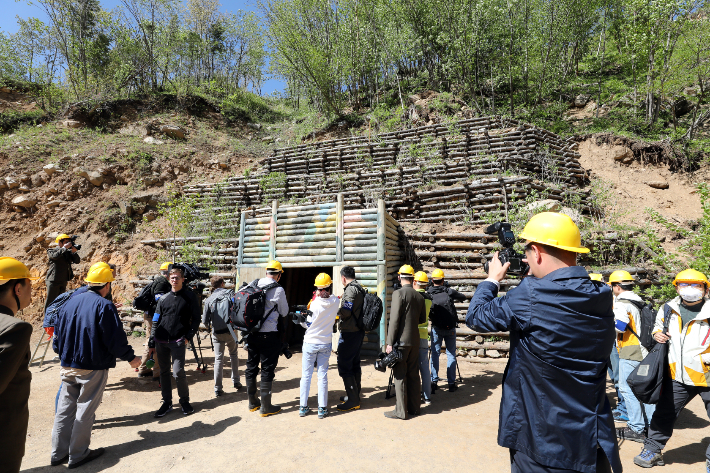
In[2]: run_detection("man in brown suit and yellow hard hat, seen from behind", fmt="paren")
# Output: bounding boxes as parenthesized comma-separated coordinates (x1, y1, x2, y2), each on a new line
(385, 264, 426, 420)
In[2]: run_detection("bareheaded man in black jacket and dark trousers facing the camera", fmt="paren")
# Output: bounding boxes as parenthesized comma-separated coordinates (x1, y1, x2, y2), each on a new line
(148, 266, 202, 417)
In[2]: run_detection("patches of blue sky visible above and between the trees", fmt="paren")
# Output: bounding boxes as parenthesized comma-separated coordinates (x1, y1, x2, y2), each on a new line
(0, 0, 286, 95)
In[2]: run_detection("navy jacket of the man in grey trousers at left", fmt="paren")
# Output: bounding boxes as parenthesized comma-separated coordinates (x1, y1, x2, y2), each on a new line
(52, 291, 136, 370)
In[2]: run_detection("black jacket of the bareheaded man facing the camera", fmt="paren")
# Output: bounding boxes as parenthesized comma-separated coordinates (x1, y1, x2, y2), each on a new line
(150, 287, 202, 342)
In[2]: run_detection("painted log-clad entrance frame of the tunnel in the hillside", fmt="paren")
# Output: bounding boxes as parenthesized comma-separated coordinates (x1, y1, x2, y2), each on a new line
(236, 194, 403, 355)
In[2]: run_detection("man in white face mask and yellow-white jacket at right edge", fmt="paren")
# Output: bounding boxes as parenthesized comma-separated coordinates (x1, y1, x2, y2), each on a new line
(634, 269, 710, 471)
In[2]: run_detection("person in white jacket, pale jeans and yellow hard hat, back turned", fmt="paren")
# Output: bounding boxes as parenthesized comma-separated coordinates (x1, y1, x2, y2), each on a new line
(298, 273, 340, 419)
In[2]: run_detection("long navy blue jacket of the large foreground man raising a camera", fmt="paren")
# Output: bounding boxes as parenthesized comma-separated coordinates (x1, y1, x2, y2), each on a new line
(466, 266, 622, 473)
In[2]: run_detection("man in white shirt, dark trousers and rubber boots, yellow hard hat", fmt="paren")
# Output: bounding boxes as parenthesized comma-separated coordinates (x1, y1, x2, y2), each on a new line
(244, 260, 289, 417)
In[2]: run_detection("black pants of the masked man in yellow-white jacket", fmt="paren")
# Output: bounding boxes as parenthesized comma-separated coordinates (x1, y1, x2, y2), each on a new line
(644, 380, 710, 460)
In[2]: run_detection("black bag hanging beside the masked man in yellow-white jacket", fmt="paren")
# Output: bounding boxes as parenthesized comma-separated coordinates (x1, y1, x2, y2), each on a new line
(626, 304, 671, 404)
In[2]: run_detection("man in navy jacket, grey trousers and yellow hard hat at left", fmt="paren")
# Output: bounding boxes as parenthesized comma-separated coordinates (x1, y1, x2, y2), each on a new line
(51, 263, 141, 468)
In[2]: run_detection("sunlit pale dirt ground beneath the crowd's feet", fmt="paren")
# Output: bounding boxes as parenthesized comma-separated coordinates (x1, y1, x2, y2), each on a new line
(22, 332, 710, 473)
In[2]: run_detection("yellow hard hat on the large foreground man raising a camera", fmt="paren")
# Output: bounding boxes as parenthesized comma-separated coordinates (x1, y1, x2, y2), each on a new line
(520, 212, 589, 253)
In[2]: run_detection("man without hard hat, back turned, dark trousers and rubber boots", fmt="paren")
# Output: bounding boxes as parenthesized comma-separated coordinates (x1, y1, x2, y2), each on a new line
(338, 266, 365, 411)
